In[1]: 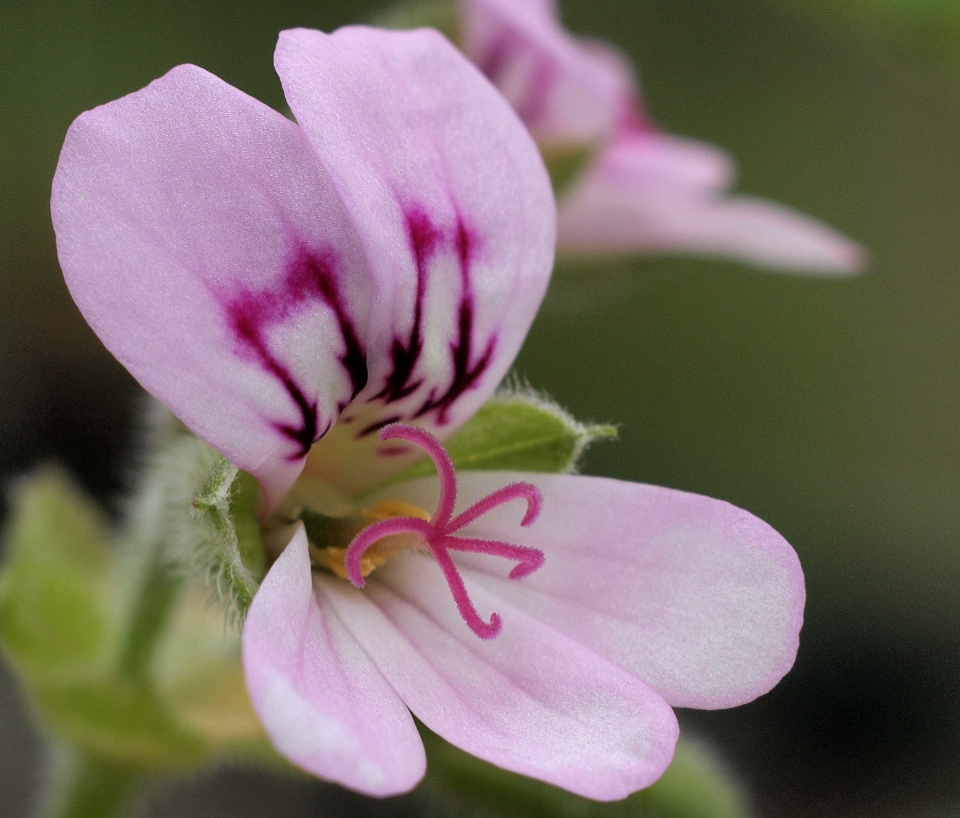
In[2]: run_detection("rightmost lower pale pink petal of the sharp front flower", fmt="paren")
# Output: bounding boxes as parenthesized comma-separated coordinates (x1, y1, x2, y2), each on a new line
(376, 472, 804, 709)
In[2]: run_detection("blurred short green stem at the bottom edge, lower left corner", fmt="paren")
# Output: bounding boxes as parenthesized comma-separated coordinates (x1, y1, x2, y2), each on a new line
(40, 751, 140, 818)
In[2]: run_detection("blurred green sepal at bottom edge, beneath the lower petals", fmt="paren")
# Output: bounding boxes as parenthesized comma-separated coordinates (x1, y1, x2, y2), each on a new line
(420, 726, 750, 818)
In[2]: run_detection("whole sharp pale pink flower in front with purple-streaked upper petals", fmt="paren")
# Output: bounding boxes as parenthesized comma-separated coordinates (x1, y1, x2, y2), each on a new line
(52, 27, 804, 800)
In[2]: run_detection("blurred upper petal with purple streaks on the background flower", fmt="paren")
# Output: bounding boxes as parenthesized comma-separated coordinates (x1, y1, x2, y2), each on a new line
(459, 0, 635, 150)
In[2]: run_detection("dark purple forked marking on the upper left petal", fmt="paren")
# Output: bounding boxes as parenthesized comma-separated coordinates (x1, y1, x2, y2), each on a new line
(225, 246, 367, 460)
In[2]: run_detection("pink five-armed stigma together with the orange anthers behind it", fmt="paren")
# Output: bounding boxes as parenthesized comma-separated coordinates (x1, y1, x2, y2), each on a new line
(344, 423, 544, 639)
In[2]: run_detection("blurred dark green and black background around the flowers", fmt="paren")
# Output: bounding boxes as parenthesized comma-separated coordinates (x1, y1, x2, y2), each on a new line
(0, 0, 960, 818)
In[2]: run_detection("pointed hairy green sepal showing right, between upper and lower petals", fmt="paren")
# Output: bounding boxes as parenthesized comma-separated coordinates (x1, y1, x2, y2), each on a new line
(397, 388, 617, 481)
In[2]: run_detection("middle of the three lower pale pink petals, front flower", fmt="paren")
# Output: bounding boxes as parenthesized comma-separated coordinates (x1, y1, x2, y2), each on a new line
(318, 552, 677, 801)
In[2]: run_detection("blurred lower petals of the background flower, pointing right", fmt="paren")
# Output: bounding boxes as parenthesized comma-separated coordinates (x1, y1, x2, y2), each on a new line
(557, 131, 864, 273)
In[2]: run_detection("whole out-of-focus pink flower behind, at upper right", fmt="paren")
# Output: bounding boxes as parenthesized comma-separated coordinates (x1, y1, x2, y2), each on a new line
(459, 0, 864, 273)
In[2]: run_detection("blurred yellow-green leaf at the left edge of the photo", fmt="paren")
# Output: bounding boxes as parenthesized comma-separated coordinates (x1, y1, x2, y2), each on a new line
(0, 468, 112, 673)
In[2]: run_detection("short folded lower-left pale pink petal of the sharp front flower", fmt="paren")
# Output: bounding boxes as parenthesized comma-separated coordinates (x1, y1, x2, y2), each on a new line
(243, 527, 426, 796)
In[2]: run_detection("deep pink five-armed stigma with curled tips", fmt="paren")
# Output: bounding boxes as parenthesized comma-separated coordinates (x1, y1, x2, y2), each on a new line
(344, 423, 544, 639)
